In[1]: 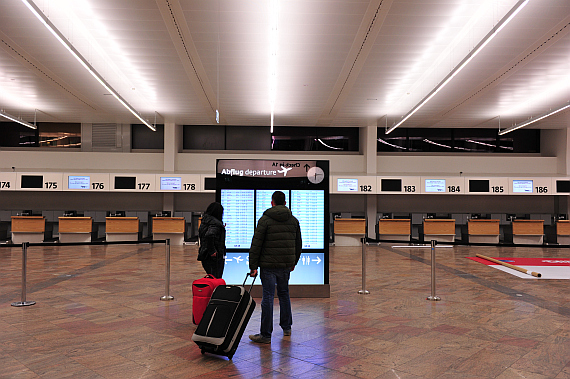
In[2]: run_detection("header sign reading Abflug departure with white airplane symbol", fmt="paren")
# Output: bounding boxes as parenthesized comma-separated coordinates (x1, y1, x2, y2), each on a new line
(218, 159, 317, 178)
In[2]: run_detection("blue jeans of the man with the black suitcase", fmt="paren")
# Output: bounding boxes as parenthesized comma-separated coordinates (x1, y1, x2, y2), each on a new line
(259, 268, 293, 338)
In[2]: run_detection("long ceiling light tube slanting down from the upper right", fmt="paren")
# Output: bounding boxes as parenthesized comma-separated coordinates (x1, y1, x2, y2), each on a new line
(386, 0, 529, 134)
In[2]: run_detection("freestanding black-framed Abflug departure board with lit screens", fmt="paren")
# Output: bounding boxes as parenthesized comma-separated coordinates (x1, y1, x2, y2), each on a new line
(215, 159, 328, 286)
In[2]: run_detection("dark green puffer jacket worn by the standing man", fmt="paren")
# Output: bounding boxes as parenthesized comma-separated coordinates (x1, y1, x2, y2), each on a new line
(249, 205, 303, 270)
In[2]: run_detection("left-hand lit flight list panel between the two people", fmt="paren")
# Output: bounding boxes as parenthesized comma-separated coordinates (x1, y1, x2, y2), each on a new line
(221, 189, 255, 249)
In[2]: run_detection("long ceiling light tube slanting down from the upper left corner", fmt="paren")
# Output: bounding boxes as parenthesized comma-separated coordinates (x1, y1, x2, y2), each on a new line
(22, 0, 156, 132)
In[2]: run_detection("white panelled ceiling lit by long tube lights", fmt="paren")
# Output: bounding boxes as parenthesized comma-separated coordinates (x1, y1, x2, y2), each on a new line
(0, 0, 570, 128)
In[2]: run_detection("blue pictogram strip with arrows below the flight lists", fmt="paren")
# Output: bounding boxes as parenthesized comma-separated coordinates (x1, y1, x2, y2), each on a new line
(223, 252, 325, 288)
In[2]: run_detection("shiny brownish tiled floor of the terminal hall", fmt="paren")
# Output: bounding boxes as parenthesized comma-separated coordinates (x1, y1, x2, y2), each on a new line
(0, 244, 570, 379)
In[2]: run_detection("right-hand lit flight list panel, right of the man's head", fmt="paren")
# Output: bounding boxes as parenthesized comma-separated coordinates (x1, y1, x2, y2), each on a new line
(291, 190, 325, 249)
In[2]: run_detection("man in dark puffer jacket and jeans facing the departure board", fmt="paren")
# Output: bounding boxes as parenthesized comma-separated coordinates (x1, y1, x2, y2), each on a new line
(249, 191, 303, 343)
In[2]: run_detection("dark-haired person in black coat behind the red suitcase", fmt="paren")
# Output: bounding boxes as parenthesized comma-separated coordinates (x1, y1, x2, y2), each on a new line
(198, 202, 226, 279)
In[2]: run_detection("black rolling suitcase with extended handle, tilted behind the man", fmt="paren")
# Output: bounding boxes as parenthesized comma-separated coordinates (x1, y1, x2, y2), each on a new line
(192, 273, 255, 359)
